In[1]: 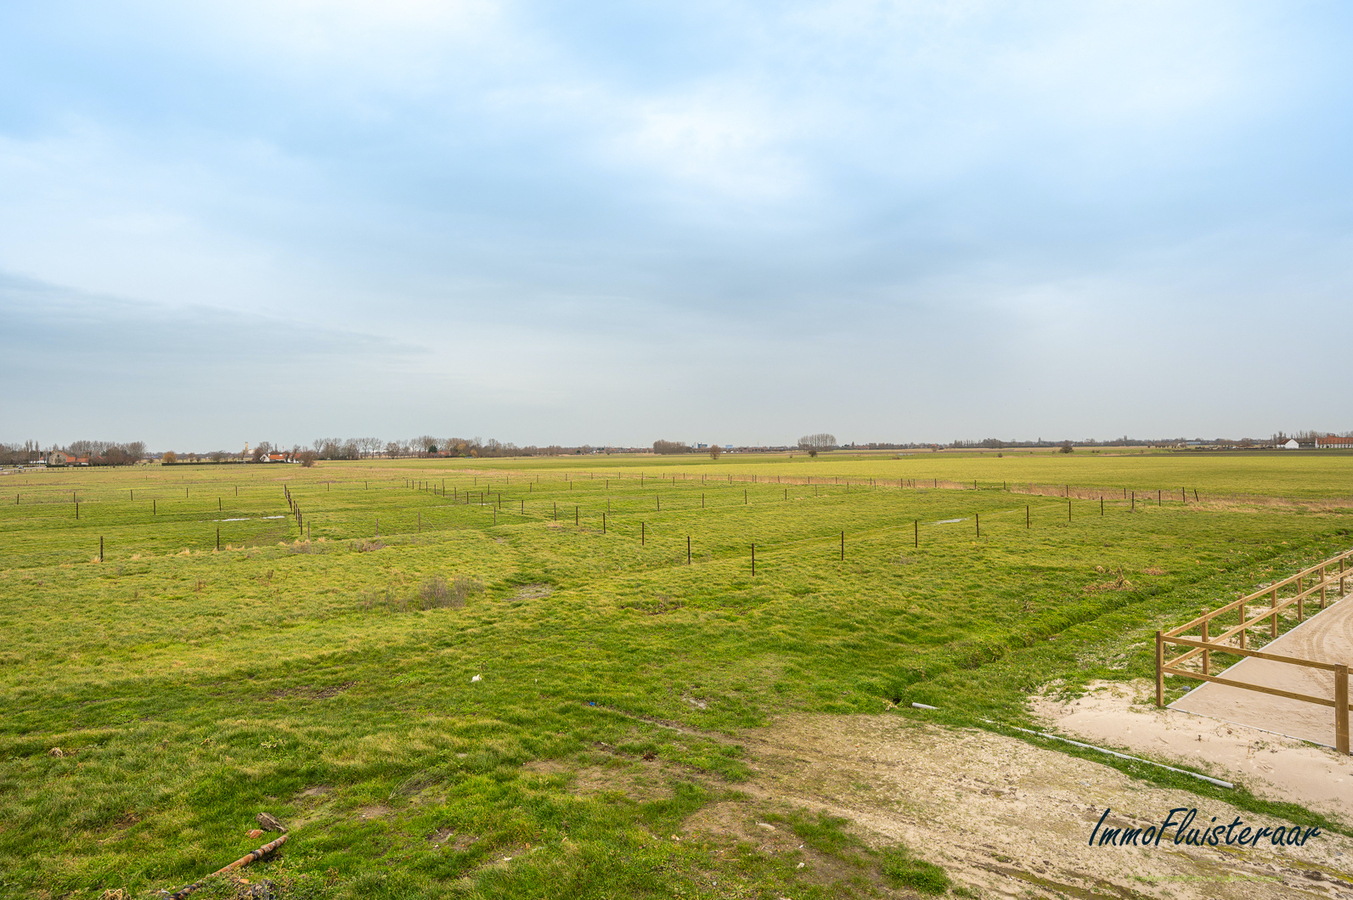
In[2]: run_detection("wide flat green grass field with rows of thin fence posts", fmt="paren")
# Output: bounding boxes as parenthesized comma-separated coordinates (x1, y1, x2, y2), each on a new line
(0, 451, 1353, 899)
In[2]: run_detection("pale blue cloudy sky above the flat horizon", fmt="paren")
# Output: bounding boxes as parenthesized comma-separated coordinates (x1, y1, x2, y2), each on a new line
(0, 0, 1353, 452)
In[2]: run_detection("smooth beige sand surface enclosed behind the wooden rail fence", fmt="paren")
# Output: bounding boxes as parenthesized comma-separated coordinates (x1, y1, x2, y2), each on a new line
(1170, 597, 1353, 746)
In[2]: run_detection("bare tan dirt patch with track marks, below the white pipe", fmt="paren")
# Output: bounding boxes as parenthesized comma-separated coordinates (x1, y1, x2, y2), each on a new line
(716, 713, 1353, 900)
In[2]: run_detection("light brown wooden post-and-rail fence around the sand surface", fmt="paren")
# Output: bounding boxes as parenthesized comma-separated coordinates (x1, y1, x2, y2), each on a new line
(1155, 549, 1353, 754)
